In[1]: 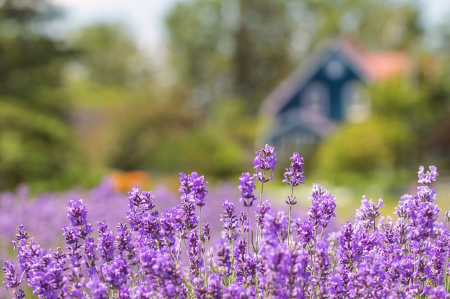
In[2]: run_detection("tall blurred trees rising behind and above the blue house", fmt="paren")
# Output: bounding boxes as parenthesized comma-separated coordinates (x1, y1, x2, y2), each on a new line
(167, 0, 421, 113)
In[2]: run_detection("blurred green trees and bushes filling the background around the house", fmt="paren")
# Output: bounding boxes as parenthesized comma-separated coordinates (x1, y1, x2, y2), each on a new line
(0, 0, 450, 216)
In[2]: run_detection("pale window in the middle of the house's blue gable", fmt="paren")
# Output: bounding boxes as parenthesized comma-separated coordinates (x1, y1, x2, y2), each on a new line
(300, 82, 330, 115)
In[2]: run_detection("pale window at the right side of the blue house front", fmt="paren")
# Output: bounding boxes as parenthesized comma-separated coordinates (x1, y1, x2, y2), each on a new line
(342, 81, 371, 123)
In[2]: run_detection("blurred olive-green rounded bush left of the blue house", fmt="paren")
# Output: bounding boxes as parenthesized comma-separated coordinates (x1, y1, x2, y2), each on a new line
(107, 88, 246, 179)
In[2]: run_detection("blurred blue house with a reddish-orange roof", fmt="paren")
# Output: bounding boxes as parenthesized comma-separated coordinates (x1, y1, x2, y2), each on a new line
(261, 38, 412, 157)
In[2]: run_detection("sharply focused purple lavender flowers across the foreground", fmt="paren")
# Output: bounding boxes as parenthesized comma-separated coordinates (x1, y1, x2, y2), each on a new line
(3, 145, 450, 299)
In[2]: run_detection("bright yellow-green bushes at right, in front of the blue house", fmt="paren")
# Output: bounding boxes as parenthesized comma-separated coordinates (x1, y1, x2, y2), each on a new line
(315, 69, 450, 184)
